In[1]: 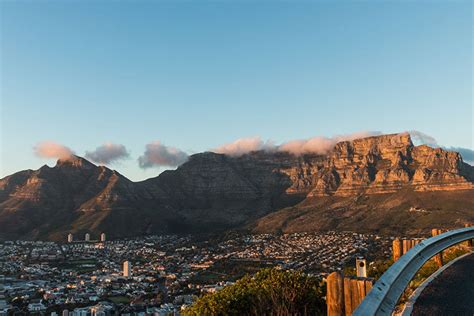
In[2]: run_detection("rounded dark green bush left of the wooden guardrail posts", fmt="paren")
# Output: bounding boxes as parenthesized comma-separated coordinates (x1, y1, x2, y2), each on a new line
(183, 269, 326, 316)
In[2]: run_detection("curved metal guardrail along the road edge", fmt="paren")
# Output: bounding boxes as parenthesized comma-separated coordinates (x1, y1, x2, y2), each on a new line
(352, 227, 474, 316)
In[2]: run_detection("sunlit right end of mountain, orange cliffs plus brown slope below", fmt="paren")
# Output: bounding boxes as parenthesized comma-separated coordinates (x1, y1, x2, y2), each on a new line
(249, 134, 474, 235)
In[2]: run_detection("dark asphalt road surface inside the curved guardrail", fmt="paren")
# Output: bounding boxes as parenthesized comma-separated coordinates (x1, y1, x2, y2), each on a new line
(412, 254, 474, 316)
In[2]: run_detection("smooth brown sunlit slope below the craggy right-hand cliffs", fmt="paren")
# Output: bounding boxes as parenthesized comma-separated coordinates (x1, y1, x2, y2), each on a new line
(254, 188, 474, 236)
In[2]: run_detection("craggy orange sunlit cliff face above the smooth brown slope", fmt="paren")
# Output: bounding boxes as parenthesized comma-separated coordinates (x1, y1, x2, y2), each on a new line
(286, 134, 474, 196)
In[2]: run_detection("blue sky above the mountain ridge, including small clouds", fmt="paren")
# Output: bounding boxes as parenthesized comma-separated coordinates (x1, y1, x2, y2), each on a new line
(0, 0, 474, 180)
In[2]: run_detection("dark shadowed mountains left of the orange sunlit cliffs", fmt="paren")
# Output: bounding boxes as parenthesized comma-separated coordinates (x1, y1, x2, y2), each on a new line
(0, 152, 304, 239)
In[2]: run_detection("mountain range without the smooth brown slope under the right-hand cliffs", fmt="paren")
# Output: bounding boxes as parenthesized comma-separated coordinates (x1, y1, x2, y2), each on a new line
(0, 134, 474, 239)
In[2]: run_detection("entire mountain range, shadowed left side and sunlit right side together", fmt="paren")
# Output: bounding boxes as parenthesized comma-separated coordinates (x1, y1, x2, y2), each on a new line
(0, 133, 474, 240)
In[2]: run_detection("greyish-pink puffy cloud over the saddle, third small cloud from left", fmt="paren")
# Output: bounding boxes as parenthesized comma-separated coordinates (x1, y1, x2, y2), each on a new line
(138, 141, 188, 169)
